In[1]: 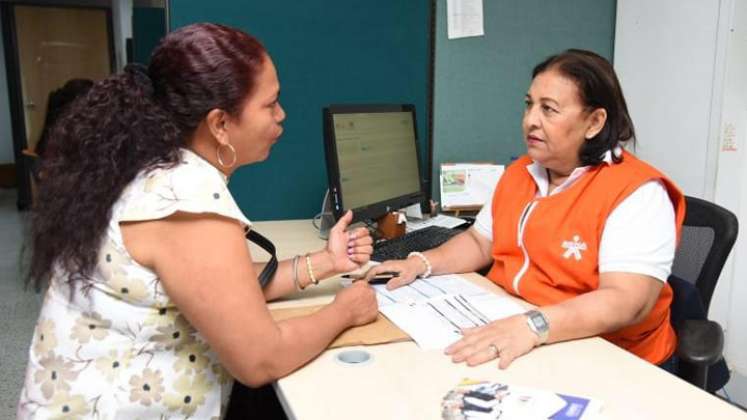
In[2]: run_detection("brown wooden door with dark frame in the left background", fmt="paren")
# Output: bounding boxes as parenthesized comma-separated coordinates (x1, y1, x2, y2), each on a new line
(3, 4, 114, 209)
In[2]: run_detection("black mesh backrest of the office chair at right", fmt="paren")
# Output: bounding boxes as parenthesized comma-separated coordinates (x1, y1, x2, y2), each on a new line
(672, 196, 739, 313)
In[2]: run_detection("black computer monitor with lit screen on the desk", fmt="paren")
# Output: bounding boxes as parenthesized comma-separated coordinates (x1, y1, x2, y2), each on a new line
(323, 105, 425, 221)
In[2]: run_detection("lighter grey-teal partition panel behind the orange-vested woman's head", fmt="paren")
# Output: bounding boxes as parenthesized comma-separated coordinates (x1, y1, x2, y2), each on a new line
(433, 0, 616, 200)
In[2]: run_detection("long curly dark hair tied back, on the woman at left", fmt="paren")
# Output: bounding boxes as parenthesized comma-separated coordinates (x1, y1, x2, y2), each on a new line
(26, 23, 267, 290)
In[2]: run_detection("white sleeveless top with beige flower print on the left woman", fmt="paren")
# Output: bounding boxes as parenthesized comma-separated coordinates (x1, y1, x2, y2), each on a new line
(18, 150, 251, 419)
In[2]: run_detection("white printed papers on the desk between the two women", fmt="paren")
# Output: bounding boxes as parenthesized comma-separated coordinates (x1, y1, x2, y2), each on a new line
(373, 275, 525, 350)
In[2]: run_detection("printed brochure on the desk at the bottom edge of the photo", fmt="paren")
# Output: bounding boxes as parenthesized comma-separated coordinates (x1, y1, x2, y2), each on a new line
(441, 379, 602, 420)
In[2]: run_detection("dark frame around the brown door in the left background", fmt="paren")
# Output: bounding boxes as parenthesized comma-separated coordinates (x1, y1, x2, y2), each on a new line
(0, 0, 116, 210)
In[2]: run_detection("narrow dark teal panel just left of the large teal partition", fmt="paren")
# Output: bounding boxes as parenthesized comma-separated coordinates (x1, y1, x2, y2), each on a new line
(132, 7, 166, 65)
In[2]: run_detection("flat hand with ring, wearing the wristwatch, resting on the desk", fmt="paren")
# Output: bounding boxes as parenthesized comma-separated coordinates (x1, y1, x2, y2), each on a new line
(445, 314, 539, 369)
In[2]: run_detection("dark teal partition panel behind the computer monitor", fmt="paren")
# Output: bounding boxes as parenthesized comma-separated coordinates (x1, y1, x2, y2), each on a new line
(169, 0, 430, 220)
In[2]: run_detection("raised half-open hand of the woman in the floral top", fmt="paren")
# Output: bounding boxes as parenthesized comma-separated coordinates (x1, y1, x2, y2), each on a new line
(326, 210, 373, 273)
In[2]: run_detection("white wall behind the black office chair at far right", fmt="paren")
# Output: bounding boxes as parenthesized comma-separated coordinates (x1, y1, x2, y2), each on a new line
(615, 0, 747, 382)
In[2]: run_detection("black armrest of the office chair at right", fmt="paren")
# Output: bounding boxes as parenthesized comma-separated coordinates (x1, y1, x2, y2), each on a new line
(677, 319, 724, 366)
